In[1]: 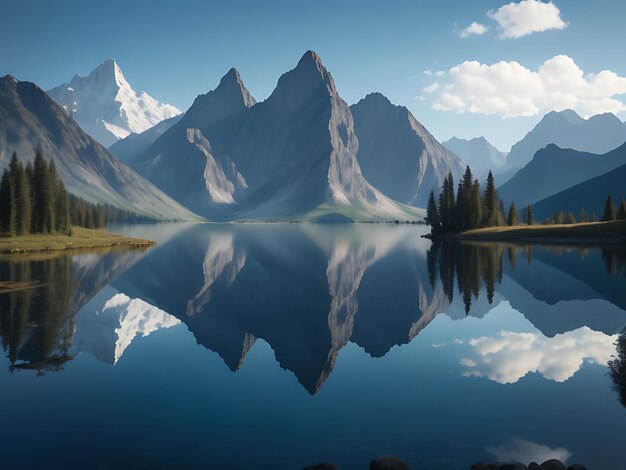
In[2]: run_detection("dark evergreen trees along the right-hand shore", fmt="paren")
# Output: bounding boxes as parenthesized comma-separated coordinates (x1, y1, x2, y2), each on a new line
(426, 166, 626, 235)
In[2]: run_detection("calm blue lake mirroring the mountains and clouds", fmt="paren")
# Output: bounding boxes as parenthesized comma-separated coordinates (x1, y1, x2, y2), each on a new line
(0, 224, 626, 470)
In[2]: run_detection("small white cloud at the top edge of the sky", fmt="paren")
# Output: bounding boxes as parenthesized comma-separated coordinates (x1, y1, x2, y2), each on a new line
(487, 0, 567, 38)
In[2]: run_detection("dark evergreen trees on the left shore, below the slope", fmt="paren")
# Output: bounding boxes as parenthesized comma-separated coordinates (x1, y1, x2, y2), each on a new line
(0, 152, 146, 236)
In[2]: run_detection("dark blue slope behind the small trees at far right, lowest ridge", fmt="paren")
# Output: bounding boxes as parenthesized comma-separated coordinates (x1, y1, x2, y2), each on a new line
(533, 161, 626, 220)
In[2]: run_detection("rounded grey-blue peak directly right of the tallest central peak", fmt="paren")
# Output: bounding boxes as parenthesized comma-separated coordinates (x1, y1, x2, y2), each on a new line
(350, 93, 463, 207)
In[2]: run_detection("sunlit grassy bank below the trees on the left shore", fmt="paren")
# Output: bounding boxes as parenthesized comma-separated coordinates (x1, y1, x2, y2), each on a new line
(0, 227, 155, 254)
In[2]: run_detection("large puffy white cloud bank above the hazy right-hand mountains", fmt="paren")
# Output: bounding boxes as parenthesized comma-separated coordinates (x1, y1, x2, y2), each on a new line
(431, 55, 626, 117)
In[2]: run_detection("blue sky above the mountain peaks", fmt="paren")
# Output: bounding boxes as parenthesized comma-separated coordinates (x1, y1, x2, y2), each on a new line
(0, 0, 626, 150)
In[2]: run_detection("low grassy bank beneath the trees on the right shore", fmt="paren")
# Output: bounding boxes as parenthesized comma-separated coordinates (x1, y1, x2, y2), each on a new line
(442, 220, 626, 243)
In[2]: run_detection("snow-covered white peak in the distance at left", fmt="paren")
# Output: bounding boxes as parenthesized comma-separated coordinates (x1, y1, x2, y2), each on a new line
(48, 59, 180, 147)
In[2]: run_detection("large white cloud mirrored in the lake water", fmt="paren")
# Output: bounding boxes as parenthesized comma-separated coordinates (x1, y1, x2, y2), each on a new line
(461, 326, 617, 384)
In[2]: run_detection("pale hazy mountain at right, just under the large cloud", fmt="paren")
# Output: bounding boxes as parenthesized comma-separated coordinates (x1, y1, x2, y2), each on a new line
(501, 109, 626, 176)
